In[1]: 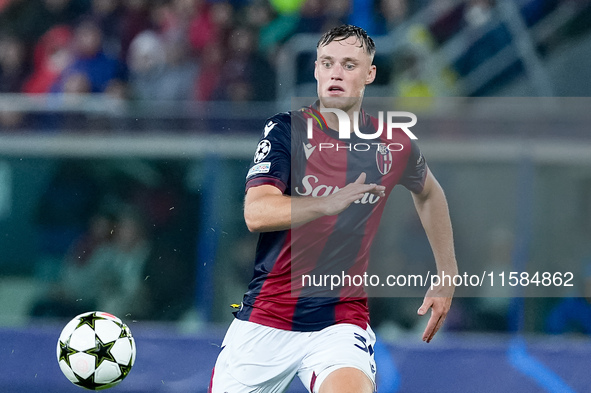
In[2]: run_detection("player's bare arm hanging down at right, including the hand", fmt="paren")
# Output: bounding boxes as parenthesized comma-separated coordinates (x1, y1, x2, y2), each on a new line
(411, 167, 458, 342)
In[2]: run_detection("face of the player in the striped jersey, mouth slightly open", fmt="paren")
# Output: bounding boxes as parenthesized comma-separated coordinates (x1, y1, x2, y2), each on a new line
(314, 37, 376, 112)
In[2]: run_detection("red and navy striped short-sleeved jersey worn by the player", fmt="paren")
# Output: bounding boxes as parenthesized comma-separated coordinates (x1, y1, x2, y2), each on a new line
(236, 105, 427, 331)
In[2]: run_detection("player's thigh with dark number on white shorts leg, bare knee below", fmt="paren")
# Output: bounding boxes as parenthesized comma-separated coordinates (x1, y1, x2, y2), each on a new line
(298, 324, 376, 393)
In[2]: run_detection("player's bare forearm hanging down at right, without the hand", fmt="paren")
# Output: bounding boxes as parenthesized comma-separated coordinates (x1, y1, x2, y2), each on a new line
(413, 184, 458, 274)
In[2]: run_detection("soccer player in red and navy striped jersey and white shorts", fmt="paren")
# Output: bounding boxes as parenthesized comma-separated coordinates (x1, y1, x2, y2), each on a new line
(210, 25, 457, 393)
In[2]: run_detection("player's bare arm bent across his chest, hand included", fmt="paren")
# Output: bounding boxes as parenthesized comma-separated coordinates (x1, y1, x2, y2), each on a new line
(244, 173, 385, 232)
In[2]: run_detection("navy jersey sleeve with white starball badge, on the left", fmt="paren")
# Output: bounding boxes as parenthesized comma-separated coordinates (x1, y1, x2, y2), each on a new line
(246, 113, 291, 193)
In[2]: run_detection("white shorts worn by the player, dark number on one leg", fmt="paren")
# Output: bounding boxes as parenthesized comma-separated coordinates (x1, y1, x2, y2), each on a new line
(210, 319, 376, 393)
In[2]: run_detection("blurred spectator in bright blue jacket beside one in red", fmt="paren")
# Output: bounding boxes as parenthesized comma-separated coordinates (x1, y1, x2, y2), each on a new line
(55, 19, 126, 93)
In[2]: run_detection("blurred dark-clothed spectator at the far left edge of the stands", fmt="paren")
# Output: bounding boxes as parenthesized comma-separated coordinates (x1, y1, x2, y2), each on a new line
(0, 36, 28, 93)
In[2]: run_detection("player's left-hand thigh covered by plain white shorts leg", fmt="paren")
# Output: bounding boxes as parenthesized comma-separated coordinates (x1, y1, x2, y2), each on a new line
(210, 320, 302, 393)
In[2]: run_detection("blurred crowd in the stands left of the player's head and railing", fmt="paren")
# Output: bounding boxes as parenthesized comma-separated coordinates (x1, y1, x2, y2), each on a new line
(0, 0, 282, 100)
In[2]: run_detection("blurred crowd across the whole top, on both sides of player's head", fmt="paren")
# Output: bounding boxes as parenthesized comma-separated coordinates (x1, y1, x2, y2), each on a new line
(0, 0, 580, 108)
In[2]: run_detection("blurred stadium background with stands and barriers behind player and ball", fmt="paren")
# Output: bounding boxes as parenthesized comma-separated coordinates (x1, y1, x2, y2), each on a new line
(0, 0, 591, 393)
